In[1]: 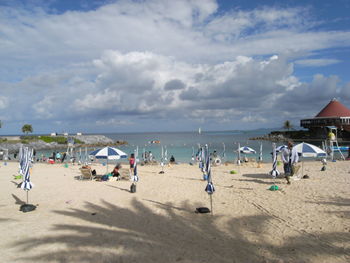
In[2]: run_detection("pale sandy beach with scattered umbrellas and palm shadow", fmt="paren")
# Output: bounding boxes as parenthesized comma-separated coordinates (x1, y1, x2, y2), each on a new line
(0, 161, 350, 263)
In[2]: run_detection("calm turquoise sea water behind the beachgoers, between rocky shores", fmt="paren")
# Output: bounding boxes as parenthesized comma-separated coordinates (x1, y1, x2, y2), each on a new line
(21, 129, 334, 163)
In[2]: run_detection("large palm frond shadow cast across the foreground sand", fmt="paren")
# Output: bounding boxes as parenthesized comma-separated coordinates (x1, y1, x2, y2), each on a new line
(11, 199, 349, 262)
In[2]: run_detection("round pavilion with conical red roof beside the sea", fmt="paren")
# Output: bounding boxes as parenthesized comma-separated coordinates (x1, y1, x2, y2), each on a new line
(300, 99, 350, 132)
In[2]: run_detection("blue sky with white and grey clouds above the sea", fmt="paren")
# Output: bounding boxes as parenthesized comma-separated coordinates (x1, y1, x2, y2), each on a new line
(0, 0, 350, 134)
